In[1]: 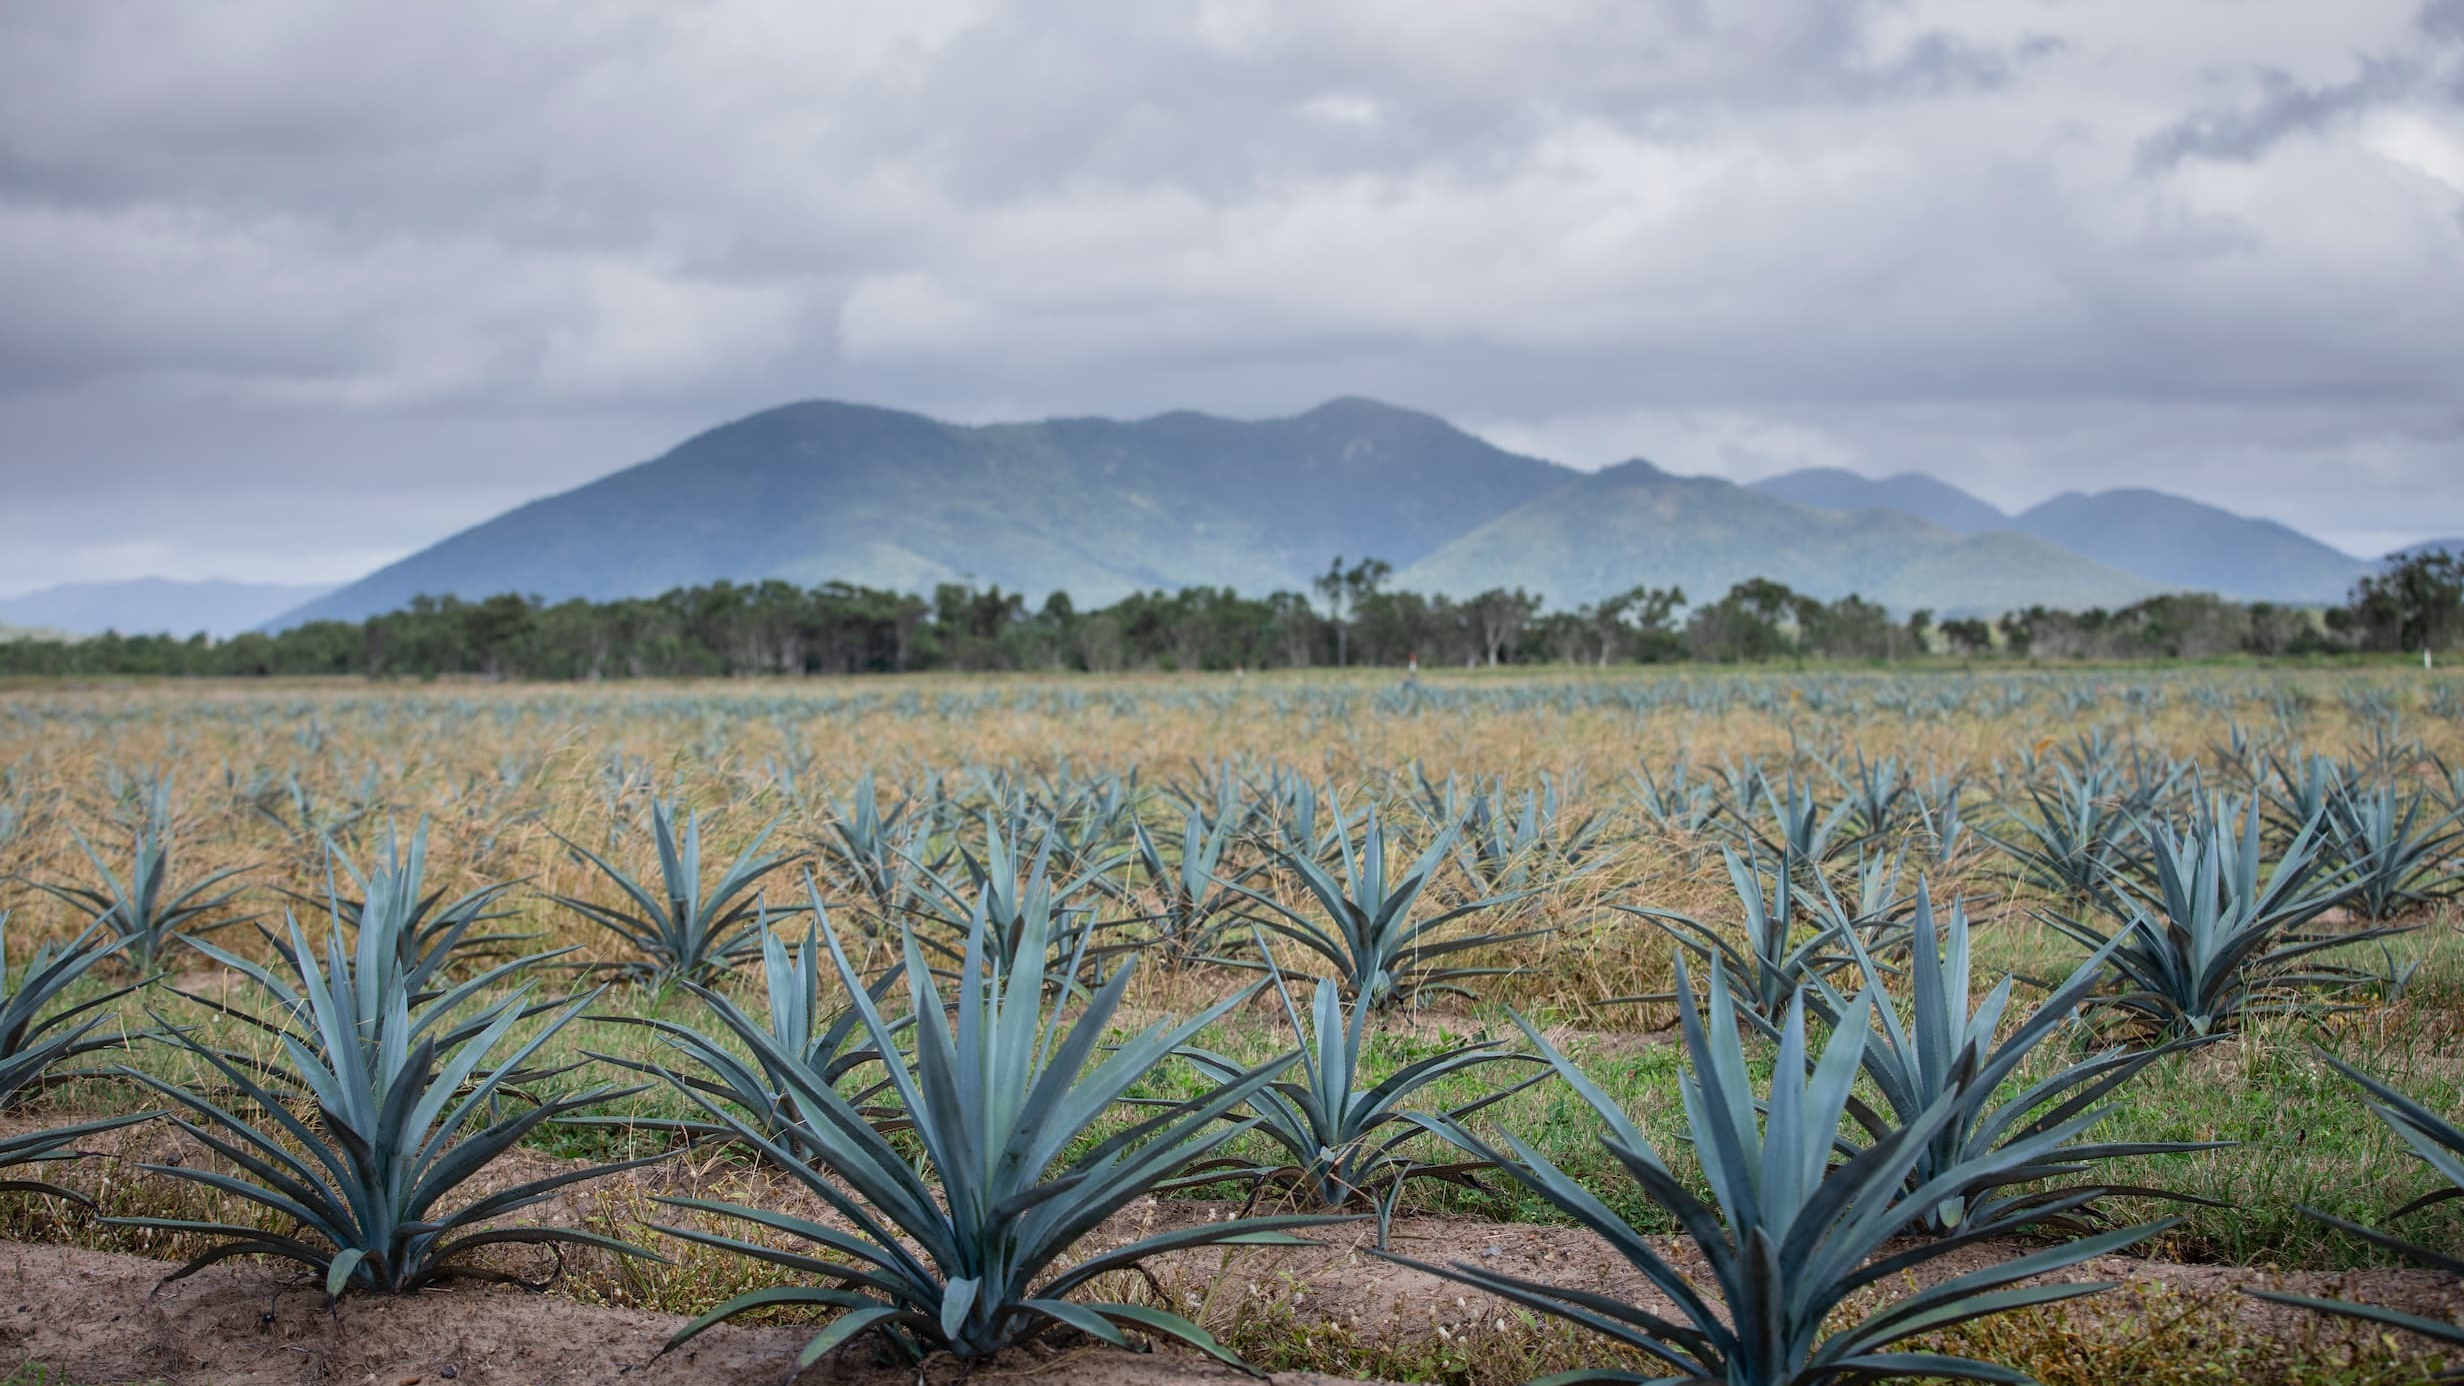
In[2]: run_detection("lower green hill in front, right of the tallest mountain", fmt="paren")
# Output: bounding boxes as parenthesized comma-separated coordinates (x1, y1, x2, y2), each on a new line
(1395, 461, 2156, 617)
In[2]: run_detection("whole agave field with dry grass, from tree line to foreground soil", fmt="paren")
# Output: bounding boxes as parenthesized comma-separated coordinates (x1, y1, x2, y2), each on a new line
(0, 668, 2464, 1386)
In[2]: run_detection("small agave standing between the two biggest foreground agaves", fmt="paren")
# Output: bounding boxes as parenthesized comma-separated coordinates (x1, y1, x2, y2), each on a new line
(1180, 942, 1547, 1211)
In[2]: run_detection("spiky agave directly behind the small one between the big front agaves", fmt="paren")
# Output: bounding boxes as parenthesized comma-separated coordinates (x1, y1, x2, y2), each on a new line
(1232, 809, 1552, 1009)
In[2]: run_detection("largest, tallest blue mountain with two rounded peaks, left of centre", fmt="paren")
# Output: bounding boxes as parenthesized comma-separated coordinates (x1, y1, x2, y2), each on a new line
(283, 400, 1577, 624)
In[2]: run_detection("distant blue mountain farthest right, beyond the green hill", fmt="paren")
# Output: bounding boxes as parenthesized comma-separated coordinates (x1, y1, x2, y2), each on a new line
(2011, 488, 2373, 602)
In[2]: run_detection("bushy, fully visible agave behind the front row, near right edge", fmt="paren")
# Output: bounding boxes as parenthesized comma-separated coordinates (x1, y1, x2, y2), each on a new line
(2050, 804, 2405, 1036)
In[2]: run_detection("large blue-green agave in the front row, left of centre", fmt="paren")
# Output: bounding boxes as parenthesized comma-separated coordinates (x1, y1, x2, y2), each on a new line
(660, 873, 1326, 1366)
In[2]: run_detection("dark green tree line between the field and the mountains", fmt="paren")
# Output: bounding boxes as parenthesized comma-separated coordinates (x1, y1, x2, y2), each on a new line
(0, 552, 2464, 678)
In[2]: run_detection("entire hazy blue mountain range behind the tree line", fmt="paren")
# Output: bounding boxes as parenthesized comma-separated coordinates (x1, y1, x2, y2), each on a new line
(0, 400, 2370, 629)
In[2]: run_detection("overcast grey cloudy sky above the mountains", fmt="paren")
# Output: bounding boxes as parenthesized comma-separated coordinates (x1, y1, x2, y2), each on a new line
(0, 0, 2464, 592)
